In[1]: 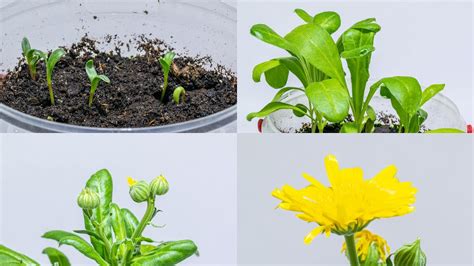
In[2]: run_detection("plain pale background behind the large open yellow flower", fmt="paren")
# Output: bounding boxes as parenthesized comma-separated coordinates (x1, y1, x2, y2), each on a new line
(237, 134, 473, 266)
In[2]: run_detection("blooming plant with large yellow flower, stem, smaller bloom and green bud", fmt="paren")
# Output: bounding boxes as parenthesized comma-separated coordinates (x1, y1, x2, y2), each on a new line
(272, 155, 426, 266)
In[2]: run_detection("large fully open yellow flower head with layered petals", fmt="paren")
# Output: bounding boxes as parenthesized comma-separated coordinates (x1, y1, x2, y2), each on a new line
(272, 155, 416, 244)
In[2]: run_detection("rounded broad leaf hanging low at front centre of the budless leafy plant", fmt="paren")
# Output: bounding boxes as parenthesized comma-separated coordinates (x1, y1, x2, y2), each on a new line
(305, 79, 349, 122)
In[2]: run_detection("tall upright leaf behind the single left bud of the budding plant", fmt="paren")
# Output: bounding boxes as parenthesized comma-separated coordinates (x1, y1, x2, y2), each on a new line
(84, 169, 113, 255)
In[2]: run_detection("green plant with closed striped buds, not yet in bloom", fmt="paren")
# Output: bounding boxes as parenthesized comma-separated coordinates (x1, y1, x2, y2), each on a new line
(0, 169, 197, 266)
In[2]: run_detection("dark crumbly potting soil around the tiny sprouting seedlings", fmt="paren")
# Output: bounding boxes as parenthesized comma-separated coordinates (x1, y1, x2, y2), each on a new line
(0, 36, 237, 128)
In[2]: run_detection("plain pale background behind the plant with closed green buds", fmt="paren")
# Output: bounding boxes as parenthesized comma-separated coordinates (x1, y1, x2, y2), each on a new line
(0, 134, 237, 265)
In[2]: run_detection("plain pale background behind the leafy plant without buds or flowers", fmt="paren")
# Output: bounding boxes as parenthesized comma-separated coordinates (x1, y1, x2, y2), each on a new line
(237, 0, 473, 132)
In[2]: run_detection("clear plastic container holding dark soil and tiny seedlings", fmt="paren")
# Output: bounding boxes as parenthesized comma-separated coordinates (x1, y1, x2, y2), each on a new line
(0, 0, 237, 133)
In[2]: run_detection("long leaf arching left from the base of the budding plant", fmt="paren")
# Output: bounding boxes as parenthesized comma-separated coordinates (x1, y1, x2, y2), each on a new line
(42, 230, 108, 265)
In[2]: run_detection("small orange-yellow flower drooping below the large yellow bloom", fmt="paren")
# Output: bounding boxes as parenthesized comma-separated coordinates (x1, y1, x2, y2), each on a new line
(341, 230, 390, 261)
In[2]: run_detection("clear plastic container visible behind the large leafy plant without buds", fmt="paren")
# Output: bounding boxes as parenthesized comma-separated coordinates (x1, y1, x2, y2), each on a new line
(261, 92, 466, 133)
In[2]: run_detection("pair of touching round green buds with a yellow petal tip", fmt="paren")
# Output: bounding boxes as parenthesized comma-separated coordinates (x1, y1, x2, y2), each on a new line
(128, 175, 169, 203)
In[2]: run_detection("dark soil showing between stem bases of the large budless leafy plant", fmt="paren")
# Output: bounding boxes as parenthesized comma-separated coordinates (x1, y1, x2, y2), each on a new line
(296, 113, 427, 133)
